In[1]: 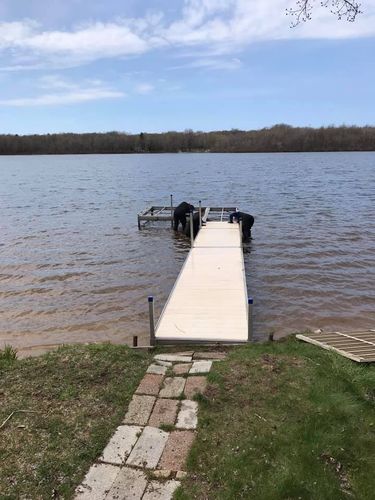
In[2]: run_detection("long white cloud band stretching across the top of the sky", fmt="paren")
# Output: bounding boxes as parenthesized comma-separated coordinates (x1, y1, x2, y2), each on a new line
(0, 0, 375, 71)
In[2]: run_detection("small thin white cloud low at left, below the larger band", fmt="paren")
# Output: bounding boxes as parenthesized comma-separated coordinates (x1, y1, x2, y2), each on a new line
(0, 75, 125, 107)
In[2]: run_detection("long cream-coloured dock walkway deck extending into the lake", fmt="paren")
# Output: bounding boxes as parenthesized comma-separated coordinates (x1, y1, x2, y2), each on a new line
(155, 221, 249, 344)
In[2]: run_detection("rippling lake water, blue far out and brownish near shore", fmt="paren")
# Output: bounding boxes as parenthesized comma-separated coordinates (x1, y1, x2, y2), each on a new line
(0, 153, 375, 348)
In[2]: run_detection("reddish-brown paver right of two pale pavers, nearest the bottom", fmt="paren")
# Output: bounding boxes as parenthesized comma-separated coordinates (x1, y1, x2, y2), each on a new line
(158, 431, 195, 471)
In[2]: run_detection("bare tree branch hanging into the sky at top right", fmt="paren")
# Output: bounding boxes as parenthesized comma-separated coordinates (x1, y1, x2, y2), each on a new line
(286, 0, 362, 28)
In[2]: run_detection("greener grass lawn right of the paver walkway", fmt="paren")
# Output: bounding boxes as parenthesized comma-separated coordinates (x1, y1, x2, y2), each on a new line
(175, 339, 375, 500)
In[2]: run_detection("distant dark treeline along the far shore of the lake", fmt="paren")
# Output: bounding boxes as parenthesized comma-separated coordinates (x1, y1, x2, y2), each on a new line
(0, 124, 375, 155)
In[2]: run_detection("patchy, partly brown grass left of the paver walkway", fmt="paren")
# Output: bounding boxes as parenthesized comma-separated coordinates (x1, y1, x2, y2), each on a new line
(0, 344, 150, 500)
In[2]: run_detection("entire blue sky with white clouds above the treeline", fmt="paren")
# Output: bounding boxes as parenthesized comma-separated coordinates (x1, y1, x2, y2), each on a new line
(0, 0, 375, 134)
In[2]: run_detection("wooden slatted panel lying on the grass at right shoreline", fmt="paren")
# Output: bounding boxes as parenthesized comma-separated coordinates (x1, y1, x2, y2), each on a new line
(296, 330, 375, 363)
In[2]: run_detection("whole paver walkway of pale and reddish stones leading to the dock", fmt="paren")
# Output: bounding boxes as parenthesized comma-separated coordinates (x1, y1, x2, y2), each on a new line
(75, 351, 225, 500)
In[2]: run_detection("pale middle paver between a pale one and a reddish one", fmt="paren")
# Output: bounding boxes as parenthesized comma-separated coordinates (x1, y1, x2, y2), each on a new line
(126, 427, 169, 469)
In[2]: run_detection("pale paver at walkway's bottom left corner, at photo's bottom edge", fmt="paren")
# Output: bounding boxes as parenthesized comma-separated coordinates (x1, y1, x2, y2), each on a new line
(74, 464, 120, 500)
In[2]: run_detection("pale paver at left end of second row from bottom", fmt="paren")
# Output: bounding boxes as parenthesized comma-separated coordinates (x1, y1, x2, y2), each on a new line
(99, 425, 142, 465)
